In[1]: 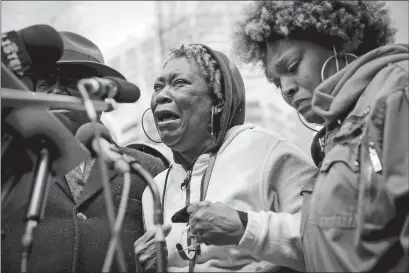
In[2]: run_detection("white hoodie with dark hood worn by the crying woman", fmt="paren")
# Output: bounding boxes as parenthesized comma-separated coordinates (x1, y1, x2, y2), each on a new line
(142, 44, 316, 272)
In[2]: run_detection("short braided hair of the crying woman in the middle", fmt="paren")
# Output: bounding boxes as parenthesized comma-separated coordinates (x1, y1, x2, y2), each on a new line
(168, 45, 225, 104)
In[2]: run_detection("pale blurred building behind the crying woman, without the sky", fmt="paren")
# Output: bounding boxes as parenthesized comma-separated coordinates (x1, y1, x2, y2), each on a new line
(107, 1, 313, 154)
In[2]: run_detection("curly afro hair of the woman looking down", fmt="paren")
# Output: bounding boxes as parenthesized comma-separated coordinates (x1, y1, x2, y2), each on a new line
(233, 1, 396, 64)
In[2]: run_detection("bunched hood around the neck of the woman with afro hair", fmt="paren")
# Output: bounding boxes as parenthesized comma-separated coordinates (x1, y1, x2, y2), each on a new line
(312, 45, 409, 126)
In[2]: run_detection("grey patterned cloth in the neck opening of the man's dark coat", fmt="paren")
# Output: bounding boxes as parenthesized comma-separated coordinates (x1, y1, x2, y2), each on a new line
(77, 159, 117, 205)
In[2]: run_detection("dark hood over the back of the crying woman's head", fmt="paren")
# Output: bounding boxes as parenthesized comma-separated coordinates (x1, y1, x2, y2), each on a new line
(173, 44, 246, 163)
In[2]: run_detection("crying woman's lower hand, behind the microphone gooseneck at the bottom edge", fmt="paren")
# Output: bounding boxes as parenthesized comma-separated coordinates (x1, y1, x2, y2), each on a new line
(134, 225, 172, 272)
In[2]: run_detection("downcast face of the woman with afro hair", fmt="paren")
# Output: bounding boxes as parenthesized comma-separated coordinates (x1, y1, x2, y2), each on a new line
(265, 39, 336, 123)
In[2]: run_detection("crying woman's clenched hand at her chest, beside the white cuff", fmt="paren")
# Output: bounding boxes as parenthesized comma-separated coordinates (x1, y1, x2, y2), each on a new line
(187, 201, 245, 246)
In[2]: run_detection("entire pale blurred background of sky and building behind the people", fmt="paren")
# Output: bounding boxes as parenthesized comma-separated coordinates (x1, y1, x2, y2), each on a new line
(1, 1, 409, 159)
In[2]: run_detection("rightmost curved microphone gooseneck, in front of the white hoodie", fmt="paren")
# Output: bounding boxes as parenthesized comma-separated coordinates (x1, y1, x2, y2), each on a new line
(130, 161, 167, 272)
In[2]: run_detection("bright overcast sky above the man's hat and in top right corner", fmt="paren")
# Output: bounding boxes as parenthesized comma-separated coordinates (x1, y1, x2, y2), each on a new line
(1, 1, 409, 57)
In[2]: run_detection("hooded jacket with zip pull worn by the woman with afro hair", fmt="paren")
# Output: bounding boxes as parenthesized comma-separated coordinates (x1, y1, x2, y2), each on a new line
(301, 45, 409, 272)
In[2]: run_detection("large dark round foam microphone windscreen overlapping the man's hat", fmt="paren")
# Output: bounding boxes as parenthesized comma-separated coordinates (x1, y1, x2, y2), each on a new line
(17, 25, 64, 71)
